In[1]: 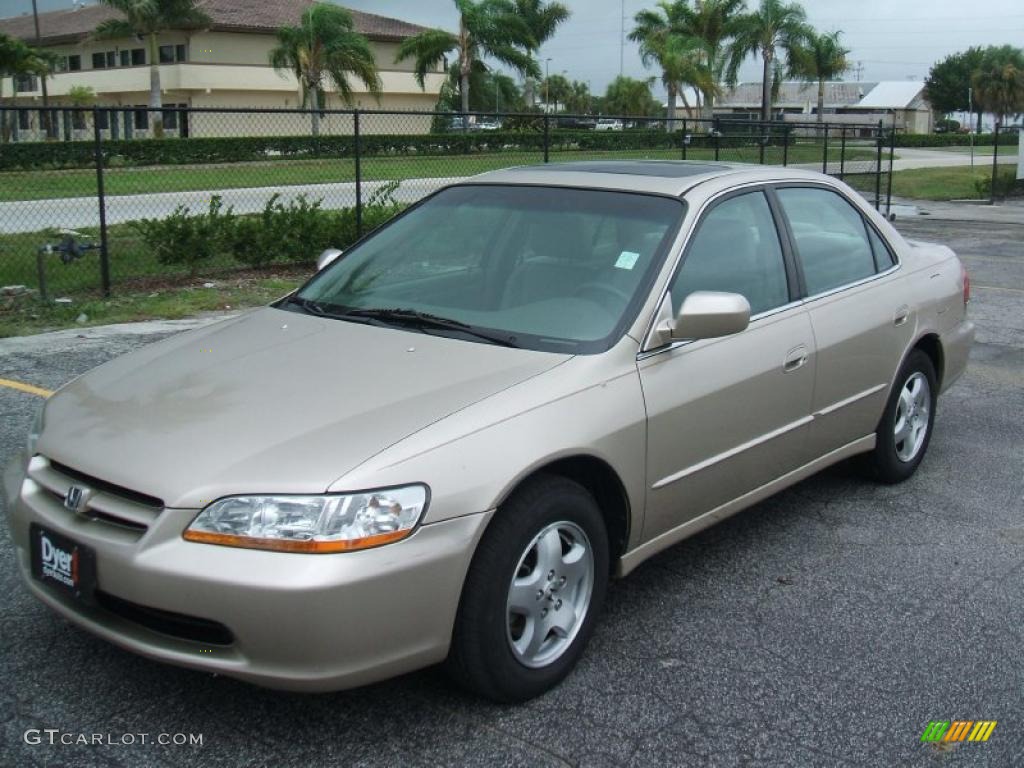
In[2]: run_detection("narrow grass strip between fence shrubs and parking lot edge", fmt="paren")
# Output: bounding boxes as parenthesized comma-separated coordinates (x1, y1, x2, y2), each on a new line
(0, 270, 308, 338)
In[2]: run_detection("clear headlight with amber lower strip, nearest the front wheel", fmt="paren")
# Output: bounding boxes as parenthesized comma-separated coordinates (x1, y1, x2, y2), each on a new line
(184, 485, 427, 552)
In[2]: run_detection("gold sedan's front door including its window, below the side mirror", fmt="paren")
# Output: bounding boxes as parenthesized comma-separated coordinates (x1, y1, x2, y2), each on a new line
(638, 188, 814, 539)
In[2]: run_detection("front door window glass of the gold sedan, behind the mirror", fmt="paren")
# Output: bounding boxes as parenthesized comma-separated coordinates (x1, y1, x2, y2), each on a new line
(671, 191, 790, 314)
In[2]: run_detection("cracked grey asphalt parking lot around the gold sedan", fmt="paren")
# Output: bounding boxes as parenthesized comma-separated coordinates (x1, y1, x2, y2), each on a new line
(0, 209, 1024, 767)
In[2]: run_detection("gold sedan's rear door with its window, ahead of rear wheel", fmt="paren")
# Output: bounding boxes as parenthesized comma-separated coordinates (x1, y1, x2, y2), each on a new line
(775, 184, 916, 455)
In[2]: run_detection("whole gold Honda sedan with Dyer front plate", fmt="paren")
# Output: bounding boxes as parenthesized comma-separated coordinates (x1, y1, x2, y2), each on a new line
(4, 161, 974, 701)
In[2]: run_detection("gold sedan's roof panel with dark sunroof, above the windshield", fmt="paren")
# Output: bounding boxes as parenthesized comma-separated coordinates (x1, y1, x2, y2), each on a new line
(464, 160, 823, 197)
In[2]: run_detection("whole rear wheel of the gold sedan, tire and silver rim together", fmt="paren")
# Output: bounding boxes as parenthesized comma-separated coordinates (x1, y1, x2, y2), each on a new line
(868, 349, 938, 482)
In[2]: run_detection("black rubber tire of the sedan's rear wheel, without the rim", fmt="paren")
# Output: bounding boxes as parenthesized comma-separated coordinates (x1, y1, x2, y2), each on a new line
(866, 349, 938, 483)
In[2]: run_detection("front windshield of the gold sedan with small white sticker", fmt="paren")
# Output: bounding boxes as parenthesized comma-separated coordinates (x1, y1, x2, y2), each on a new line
(291, 184, 684, 352)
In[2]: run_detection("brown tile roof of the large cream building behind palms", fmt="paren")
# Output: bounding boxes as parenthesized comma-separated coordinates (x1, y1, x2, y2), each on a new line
(0, 0, 424, 44)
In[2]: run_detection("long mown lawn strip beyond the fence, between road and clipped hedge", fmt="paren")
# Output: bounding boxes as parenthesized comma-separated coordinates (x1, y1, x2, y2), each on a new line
(0, 143, 876, 199)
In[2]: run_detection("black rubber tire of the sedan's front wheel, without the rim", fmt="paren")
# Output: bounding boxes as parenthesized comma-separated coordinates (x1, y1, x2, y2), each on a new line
(446, 475, 609, 703)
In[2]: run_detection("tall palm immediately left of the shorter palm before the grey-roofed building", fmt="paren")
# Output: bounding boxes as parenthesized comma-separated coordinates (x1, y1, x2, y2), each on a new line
(727, 0, 811, 123)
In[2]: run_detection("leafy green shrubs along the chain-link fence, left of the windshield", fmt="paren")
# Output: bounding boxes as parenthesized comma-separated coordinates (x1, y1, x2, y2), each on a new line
(130, 182, 403, 274)
